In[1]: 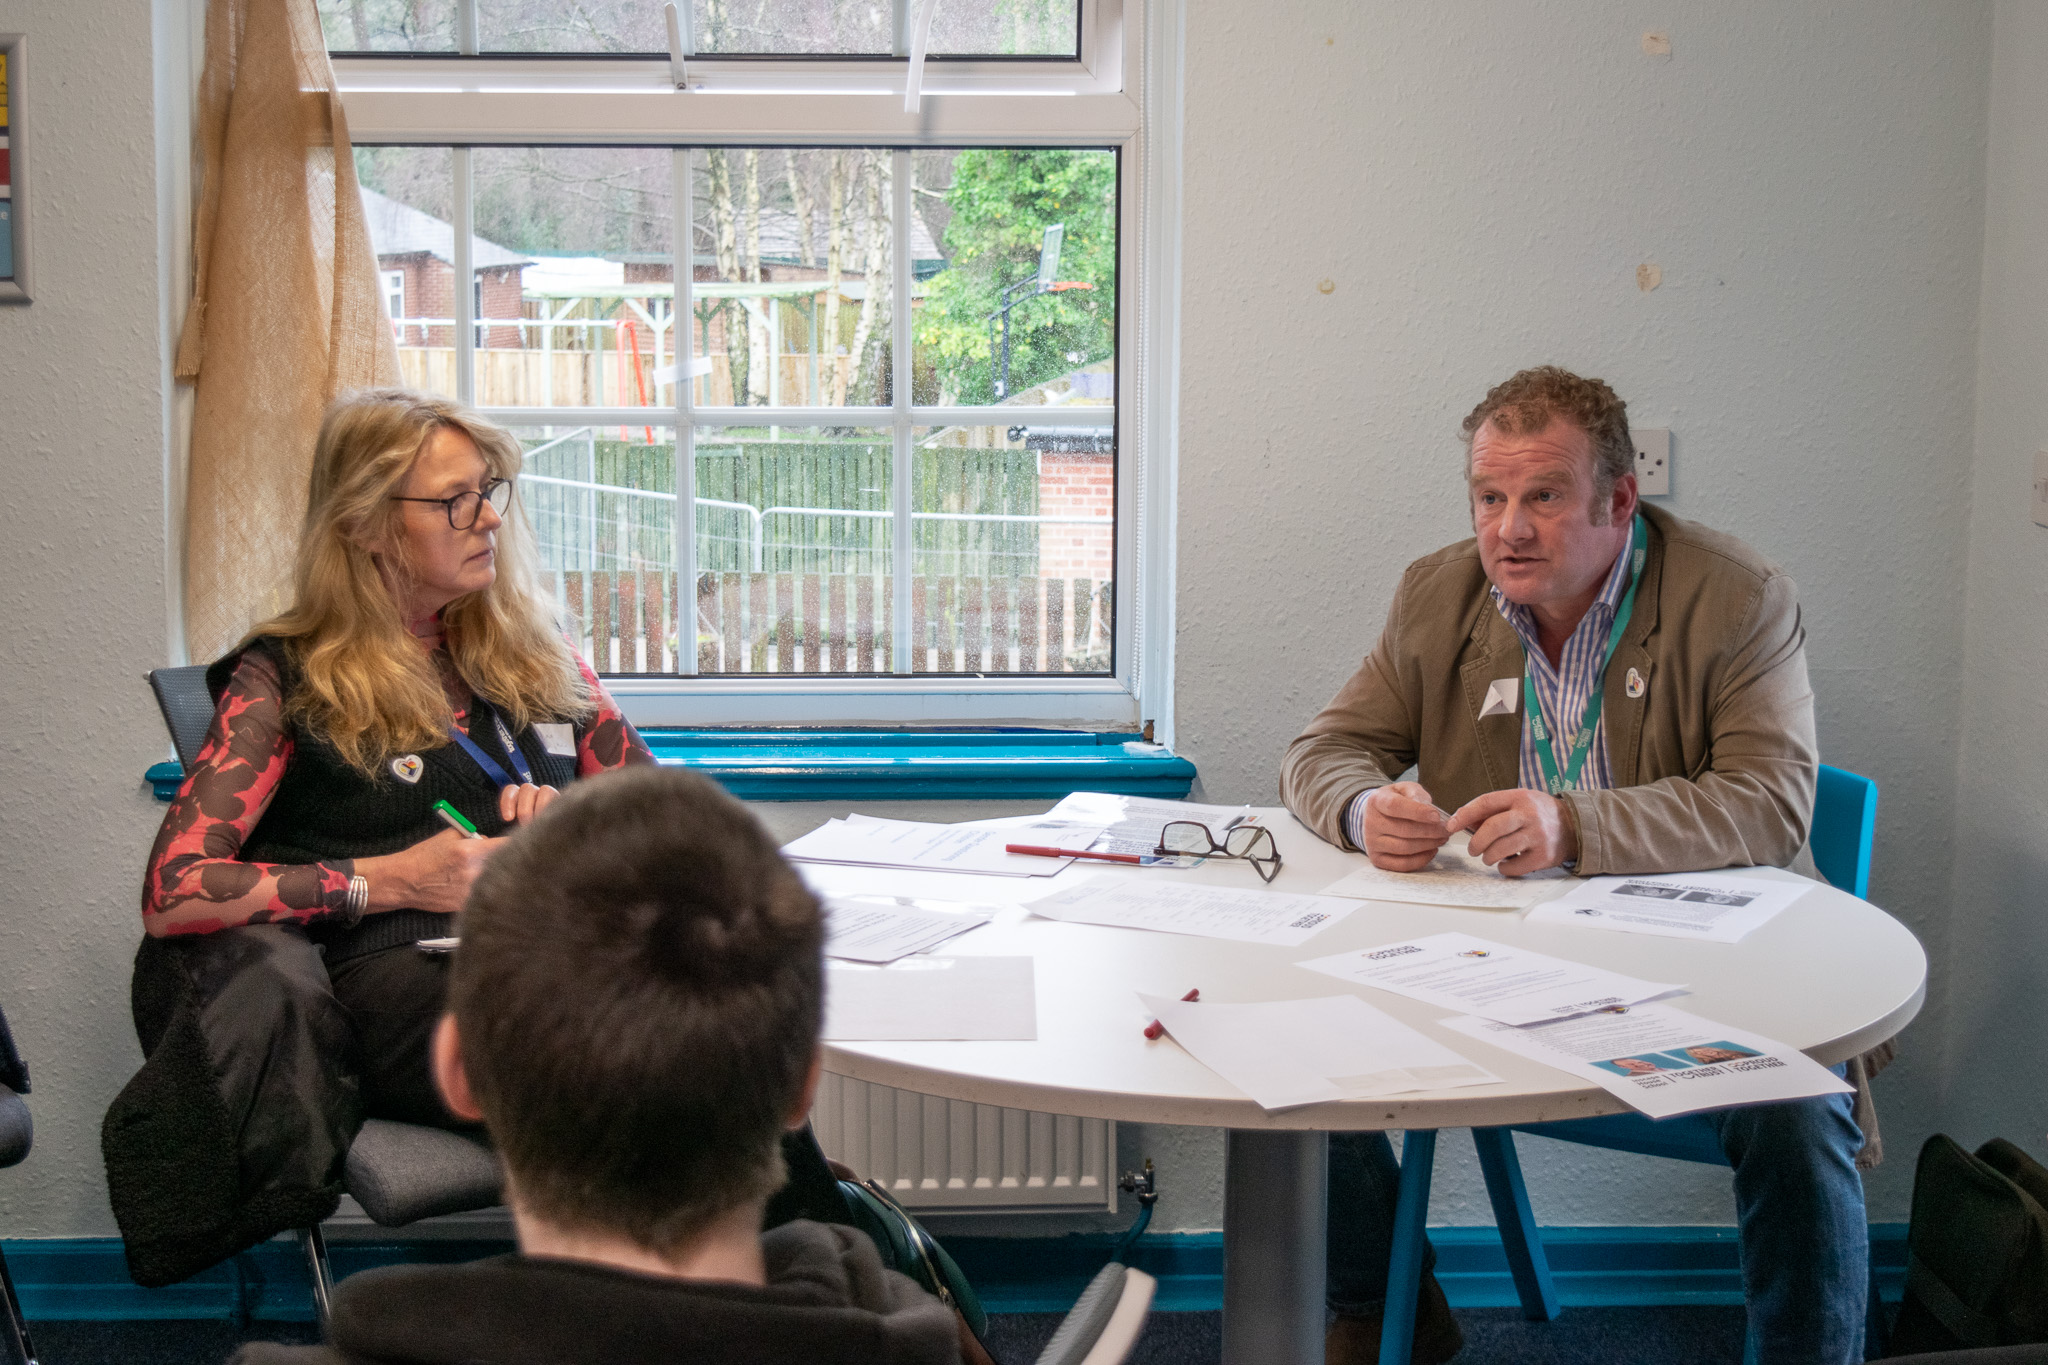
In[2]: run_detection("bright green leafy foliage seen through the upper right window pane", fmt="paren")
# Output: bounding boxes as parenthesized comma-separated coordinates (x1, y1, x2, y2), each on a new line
(918, 147, 1116, 403)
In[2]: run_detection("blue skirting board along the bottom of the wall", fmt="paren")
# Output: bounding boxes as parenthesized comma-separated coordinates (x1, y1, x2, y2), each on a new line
(0, 1224, 1907, 1322)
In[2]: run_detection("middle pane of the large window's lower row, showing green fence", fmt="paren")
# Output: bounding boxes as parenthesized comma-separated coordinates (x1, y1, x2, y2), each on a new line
(696, 428, 893, 673)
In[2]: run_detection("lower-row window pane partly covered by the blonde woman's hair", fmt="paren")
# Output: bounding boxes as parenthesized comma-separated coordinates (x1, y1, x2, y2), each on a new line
(516, 426, 678, 673)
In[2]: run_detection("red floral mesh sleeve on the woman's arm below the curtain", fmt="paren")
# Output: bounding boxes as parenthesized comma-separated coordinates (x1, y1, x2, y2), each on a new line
(141, 653, 352, 937)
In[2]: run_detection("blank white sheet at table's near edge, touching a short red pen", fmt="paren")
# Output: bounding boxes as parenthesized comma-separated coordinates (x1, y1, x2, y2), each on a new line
(1139, 995, 1499, 1109)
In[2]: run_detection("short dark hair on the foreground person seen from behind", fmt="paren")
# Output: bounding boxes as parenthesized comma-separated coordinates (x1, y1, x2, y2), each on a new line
(449, 767, 823, 1252)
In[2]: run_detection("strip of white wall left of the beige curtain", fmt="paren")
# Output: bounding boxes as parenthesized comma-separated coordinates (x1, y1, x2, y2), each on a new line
(0, 0, 168, 1236)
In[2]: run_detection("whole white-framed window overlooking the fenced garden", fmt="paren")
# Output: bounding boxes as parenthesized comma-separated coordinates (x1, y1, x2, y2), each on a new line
(319, 0, 1169, 726)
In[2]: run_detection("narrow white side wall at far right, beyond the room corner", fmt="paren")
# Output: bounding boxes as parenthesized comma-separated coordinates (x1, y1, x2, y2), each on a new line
(1942, 0, 2048, 1154)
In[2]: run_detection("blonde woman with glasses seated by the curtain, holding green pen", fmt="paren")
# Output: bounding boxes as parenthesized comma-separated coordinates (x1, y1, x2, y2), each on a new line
(104, 389, 653, 1283)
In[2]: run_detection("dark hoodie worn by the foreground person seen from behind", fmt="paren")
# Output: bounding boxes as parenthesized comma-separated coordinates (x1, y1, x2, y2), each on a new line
(231, 1222, 961, 1365)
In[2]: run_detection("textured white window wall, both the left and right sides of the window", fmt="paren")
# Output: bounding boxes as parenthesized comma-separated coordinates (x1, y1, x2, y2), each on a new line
(0, 0, 2015, 1236)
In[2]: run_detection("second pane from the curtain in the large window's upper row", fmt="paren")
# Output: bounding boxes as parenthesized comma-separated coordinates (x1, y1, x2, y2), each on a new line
(471, 147, 676, 407)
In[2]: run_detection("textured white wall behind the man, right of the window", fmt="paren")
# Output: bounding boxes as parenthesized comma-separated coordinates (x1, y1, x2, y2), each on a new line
(1161, 0, 1990, 1224)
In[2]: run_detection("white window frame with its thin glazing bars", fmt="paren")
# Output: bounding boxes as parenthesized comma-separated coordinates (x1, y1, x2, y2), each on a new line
(334, 0, 1182, 743)
